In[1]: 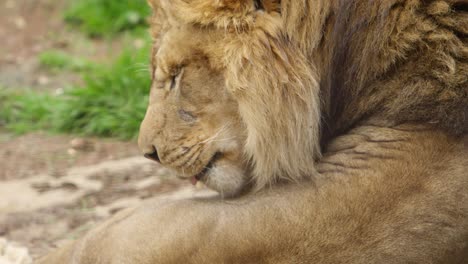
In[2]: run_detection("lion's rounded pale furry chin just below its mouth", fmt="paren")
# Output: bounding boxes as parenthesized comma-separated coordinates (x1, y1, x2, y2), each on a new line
(198, 160, 247, 198)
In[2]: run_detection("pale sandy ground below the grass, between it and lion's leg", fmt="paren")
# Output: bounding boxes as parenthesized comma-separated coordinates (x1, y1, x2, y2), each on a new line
(0, 134, 207, 264)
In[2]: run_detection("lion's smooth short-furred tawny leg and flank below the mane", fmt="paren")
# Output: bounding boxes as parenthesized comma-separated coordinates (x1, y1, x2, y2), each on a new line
(42, 127, 468, 264)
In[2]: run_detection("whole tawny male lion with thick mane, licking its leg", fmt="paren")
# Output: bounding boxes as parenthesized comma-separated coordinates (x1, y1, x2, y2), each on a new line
(40, 0, 468, 264)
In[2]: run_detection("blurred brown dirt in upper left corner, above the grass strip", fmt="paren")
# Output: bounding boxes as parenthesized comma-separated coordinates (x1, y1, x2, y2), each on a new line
(0, 0, 122, 91)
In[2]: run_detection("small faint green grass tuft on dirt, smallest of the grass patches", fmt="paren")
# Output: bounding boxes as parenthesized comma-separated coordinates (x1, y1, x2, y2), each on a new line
(38, 50, 92, 72)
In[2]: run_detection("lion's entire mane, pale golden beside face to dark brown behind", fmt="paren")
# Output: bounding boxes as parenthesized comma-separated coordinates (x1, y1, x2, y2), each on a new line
(152, 0, 468, 188)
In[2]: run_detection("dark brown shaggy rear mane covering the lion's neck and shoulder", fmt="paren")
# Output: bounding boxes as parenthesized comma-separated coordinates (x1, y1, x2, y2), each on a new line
(281, 0, 468, 139)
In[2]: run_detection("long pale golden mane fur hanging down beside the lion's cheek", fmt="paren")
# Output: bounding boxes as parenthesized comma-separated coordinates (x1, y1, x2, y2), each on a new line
(224, 12, 321, 188)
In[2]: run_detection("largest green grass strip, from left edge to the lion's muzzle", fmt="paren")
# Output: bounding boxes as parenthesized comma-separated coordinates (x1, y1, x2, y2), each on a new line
(0, 43, 150, 139)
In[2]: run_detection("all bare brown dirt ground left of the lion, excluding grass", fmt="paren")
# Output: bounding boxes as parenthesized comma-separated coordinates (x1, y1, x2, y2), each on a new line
(0, 0, 206, 264)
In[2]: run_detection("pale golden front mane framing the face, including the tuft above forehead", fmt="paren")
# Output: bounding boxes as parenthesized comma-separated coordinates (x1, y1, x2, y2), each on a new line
(153, 0, 321, 189)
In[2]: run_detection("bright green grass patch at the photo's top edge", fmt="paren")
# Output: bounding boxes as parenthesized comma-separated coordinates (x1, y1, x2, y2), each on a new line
(65, 0, 150, 37)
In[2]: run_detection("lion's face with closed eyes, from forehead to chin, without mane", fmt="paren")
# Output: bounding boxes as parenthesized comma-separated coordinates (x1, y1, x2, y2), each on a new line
(139, 28, 247, 196)
